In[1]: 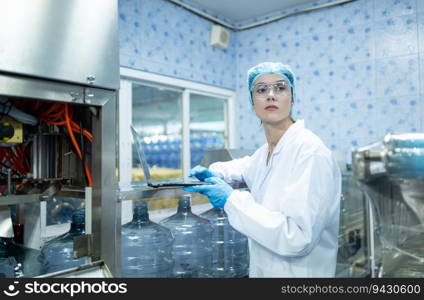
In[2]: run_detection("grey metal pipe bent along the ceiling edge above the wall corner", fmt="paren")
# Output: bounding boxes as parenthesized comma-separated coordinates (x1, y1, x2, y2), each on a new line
(168, 0, 357, 31)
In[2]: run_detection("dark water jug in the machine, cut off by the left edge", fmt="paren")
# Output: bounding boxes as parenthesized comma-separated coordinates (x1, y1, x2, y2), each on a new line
(0, 237, 41, 278)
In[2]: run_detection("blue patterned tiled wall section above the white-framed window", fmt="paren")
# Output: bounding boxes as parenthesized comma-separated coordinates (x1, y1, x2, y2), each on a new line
(118, 0, 236, 89)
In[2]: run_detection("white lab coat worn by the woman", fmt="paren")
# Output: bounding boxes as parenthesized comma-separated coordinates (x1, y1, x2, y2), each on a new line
(209, 120, 341, 277)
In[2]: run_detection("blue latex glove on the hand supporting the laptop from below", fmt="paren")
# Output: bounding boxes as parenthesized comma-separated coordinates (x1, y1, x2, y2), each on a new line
(183, 177, 233, 208)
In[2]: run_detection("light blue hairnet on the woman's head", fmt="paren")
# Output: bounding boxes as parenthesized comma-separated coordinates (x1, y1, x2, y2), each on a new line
(247, 62, 296, 105)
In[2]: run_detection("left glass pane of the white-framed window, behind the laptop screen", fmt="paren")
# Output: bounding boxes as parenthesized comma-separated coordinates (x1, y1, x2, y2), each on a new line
(132, 83, 182, 181)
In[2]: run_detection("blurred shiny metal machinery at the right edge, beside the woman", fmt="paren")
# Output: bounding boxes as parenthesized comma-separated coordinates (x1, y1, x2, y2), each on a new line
(352, 133, 424, 277)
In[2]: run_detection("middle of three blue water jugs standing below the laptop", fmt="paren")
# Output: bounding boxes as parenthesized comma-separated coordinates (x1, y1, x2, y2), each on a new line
(159, 195, 213, 278)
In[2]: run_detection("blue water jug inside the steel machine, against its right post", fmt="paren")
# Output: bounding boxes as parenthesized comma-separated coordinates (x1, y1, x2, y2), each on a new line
(40, 208, 85, 273)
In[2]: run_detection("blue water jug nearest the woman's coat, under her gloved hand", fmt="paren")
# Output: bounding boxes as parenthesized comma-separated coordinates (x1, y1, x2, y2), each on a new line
(200, 208, 249, 278)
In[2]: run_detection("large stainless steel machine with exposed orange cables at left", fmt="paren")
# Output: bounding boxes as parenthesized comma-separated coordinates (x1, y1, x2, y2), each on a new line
(0, 0, 121, 276)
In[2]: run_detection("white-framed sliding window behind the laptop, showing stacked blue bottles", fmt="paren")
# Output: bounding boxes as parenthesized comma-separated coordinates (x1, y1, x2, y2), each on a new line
(119, 68, 234, 186)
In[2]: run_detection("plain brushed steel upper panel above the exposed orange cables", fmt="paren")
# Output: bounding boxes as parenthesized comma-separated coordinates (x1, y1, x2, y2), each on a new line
(0, 0, 119, 89)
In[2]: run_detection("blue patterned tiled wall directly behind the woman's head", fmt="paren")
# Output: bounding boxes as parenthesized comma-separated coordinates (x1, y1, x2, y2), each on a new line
(236, 0, 424, 161)
